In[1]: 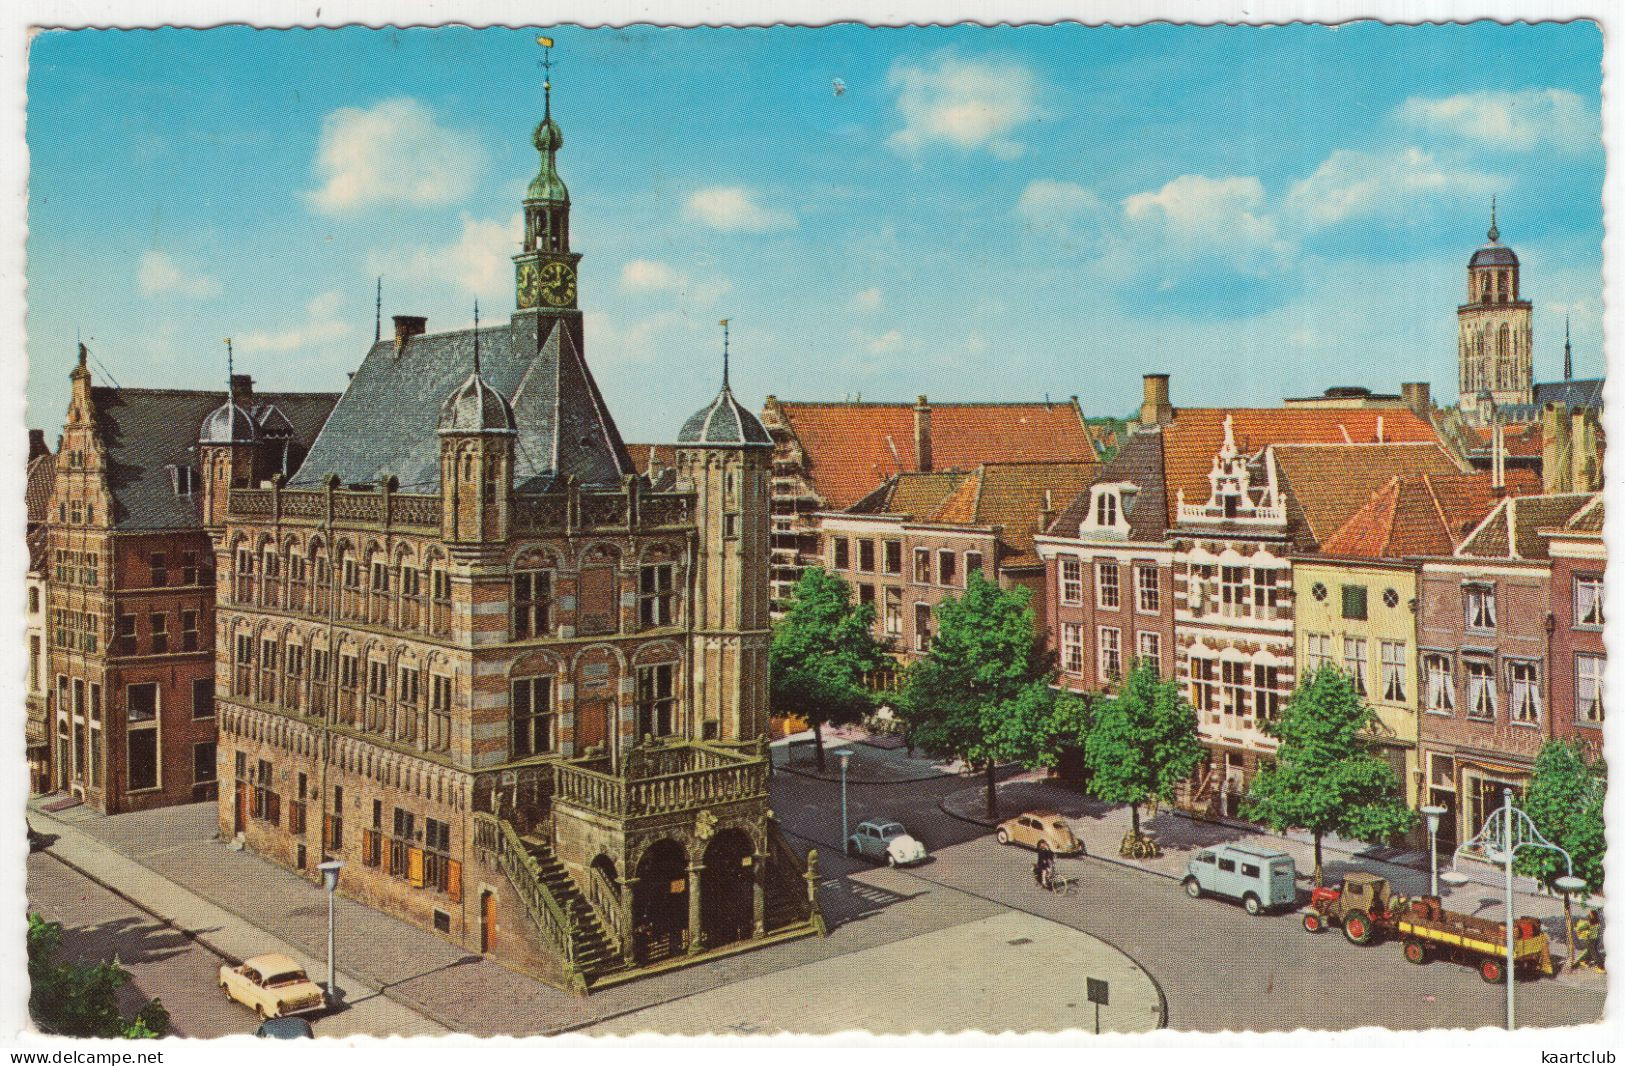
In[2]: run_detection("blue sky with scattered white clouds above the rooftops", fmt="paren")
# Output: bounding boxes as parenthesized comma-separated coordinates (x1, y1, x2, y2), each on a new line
(26, 23, 1604, 442)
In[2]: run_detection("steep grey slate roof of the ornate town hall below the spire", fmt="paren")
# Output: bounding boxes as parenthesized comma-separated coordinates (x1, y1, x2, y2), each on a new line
(293, 314, 634, 492)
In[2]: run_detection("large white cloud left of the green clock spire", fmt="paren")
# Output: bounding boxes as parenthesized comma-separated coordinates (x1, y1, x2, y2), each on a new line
(306, 98, 484, 215)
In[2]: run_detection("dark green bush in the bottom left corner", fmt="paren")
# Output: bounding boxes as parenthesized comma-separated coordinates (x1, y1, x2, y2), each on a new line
(28, 913, 169, 1040)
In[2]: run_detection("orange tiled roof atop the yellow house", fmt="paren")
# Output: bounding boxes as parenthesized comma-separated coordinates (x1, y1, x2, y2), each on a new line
(1320, 470, 1541, 559)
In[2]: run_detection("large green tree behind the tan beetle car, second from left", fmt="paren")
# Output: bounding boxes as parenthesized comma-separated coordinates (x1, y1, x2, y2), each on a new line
(897, 572, 1055, 817)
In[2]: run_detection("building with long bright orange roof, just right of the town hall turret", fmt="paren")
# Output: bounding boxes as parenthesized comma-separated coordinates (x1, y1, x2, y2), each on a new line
(762, 397, 1097, 611)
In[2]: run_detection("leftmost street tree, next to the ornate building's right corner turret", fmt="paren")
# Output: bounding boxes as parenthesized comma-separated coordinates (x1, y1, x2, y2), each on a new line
(767, 567, 886, 772)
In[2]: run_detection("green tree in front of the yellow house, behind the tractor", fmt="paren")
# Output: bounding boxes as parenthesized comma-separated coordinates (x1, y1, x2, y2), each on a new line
(1242, 666, 1417, 884)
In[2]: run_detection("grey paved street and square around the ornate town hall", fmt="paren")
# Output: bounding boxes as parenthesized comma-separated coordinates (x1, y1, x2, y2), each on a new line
(19, 746, 1604, 1035)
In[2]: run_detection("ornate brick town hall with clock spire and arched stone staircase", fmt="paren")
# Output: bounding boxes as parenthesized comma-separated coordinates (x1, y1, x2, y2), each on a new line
(205, 83, 821, 991)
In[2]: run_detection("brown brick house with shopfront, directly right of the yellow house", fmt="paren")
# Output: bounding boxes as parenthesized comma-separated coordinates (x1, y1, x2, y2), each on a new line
(1417, 494, 1601, 840)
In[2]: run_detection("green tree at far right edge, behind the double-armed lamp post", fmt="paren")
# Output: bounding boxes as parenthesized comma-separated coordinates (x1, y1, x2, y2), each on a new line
(1518, 739, 1607, 894)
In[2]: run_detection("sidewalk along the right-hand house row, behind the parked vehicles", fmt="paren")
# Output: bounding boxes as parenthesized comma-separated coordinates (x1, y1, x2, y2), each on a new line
(939, 772, 1602, 977)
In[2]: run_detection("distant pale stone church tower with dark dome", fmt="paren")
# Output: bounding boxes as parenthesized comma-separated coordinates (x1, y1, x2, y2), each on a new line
(1456, 202, 1534, 423)
